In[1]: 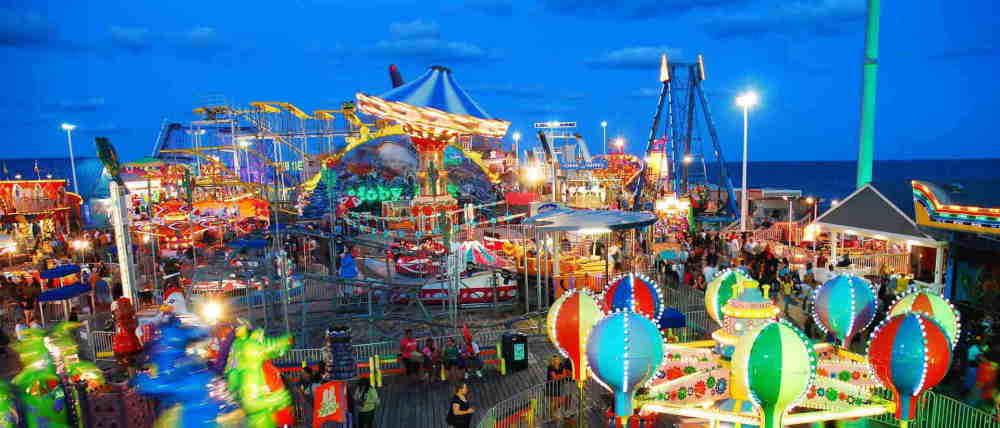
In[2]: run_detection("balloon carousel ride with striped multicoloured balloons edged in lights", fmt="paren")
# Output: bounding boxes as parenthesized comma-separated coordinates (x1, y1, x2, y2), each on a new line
(548, 271, 959, 428)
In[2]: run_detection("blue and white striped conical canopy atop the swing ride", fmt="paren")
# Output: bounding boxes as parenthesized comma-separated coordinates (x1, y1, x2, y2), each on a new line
(378, 65, 493, 119)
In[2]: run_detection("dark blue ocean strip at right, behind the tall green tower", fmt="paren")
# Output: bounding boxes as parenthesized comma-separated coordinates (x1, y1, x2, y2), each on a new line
(706, 158, 1000, 210)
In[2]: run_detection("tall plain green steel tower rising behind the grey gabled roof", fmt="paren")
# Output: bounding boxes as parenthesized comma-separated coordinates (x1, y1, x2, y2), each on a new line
(858, 0, 880, 188)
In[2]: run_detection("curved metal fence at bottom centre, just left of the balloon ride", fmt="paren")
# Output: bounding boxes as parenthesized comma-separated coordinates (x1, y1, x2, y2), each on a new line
(476, 380, 596, 428)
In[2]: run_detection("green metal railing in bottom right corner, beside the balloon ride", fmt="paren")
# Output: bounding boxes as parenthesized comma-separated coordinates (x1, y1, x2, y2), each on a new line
(868, 389, 1000, 428)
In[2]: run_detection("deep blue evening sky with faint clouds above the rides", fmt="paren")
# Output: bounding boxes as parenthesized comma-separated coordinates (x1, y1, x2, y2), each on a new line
(0, 0, 1000, 161)
